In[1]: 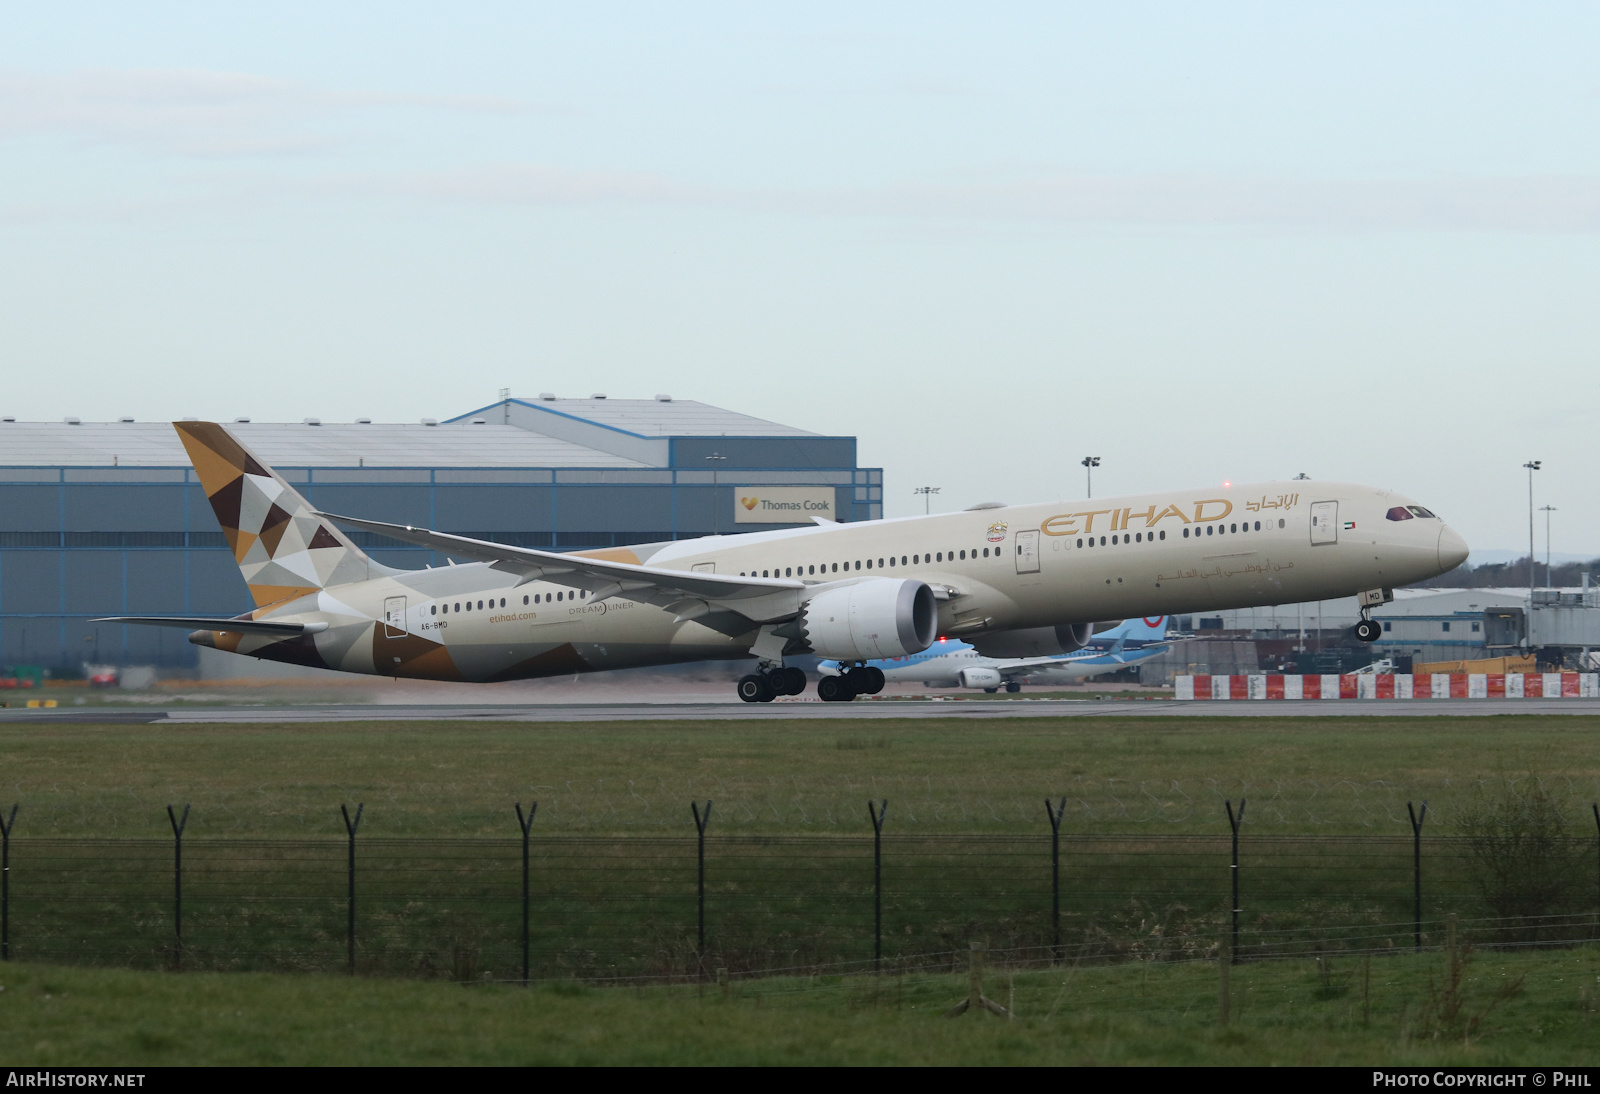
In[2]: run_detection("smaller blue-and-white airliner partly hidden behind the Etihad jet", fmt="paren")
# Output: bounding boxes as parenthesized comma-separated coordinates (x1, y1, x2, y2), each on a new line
(816, 616, 1173, 693)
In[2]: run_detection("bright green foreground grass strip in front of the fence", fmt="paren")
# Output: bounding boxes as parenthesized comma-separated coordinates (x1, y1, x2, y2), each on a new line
(0, 947, 1600, 1068)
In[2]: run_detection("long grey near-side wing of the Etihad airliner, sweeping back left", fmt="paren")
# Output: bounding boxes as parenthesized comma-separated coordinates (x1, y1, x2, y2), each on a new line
(317, 513, 808, 622)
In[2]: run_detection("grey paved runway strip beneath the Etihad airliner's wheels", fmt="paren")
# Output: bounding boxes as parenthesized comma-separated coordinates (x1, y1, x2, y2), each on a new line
(0, 699, 1600, 726)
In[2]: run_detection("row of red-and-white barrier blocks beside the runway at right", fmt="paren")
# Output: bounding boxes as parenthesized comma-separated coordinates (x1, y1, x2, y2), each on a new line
(1173, 672, 1600, 699)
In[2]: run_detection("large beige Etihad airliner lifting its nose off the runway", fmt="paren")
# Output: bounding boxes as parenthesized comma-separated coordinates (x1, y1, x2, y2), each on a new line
(100, 422, 1467, 702)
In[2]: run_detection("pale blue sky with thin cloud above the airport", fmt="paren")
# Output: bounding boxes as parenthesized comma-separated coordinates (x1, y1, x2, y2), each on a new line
(0, 0, 1600, 557)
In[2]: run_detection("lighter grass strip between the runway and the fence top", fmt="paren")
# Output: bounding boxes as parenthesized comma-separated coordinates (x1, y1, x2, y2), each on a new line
(0, 715, 1600, 836)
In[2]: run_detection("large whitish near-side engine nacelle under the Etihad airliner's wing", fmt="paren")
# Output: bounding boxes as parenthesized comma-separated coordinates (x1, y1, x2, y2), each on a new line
(800, 577, 939, 661)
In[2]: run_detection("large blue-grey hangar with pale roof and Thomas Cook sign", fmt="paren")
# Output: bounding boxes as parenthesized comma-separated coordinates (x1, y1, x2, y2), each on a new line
(0, 393, 883, 672)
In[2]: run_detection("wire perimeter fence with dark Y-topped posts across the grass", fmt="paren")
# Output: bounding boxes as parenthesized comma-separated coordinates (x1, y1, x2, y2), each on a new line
(0, 803, 1600, 982)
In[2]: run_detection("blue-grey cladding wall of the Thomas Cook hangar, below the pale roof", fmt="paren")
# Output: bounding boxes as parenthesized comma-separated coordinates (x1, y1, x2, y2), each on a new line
(0, 427, 883, 670)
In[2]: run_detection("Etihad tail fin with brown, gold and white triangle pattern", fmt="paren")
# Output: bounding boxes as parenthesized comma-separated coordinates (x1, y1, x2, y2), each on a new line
(173, 422, 395, 608)
